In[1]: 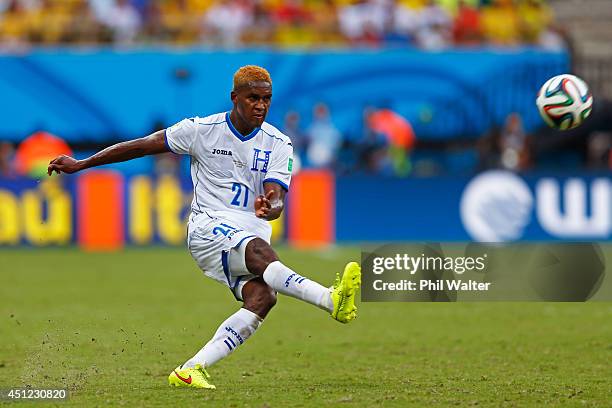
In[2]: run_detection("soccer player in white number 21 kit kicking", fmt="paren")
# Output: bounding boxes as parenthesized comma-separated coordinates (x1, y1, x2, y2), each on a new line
(47, 65, 361, 389)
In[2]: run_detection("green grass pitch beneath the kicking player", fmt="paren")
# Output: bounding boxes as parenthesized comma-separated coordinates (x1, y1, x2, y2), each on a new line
(0, 248, 612, 407)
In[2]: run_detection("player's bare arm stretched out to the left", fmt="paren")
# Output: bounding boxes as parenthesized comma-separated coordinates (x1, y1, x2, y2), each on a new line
(47, 130, 168, 175)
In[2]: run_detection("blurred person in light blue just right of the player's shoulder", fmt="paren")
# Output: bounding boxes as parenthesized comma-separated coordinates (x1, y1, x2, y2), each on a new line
(306, 103, 342, 167)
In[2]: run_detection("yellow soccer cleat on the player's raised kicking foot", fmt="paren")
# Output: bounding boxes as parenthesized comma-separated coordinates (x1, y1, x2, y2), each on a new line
(331, 262, 361, 323)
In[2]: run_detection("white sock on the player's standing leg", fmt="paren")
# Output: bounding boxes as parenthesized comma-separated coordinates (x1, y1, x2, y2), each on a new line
(183, 309, 262, 367)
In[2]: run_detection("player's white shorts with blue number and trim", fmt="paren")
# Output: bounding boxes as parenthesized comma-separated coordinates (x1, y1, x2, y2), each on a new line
(187, 213, 257, 300)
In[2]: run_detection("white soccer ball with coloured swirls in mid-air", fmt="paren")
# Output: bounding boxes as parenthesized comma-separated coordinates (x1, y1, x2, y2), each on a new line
(536, 74, 593, 130)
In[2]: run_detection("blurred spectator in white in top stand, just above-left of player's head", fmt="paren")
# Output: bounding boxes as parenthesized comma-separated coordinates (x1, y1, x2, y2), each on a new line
(203, 0, 253, 48)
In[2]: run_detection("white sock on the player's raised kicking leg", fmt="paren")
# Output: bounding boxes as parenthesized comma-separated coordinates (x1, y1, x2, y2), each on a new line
(263, 261, 334, 312)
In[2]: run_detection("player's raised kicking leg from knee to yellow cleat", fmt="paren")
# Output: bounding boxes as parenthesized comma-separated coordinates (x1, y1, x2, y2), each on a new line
(245, 238, 361, 323)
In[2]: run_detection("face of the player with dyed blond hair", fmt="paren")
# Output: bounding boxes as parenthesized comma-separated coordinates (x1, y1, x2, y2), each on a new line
(232, 82, 272, 128)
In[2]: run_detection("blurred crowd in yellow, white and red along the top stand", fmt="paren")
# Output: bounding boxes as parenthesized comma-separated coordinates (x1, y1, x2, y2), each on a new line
(0, 0, 564, 49)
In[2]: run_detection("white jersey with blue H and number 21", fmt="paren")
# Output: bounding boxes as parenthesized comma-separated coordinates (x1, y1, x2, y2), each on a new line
(166, 112, 293, 241)
